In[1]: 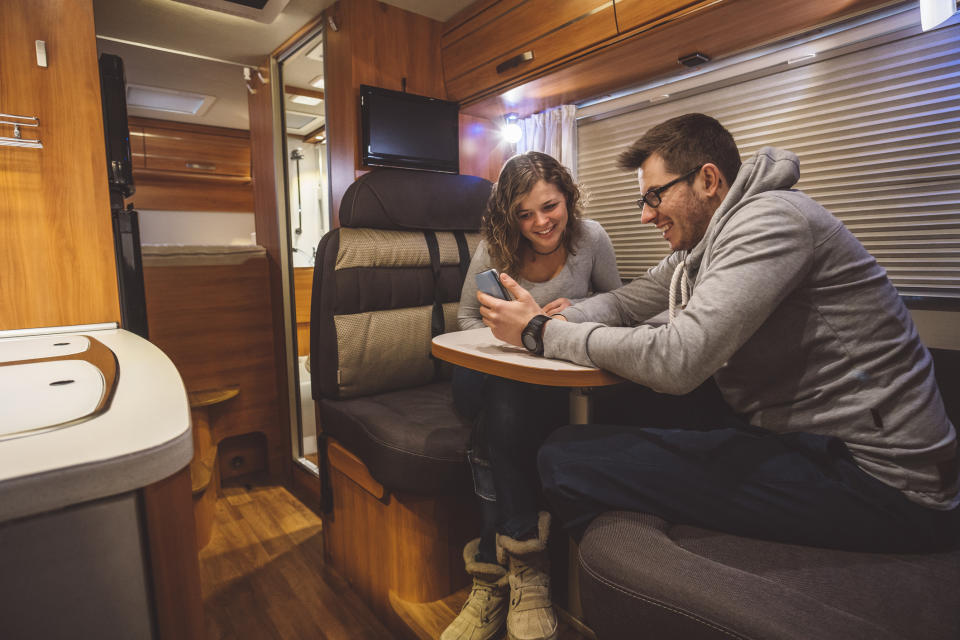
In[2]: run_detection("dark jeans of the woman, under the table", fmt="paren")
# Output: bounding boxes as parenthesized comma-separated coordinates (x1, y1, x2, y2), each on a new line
(453, 367, 569, 562)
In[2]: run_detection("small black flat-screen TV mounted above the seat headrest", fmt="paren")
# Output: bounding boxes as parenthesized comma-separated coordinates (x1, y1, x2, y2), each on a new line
(360, 85, 460, 173)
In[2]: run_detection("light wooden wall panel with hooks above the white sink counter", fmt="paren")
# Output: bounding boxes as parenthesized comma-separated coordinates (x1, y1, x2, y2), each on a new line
(0, 0, 120, 330)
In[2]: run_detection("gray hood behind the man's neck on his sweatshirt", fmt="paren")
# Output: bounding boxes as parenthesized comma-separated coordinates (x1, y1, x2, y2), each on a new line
(686, 147, 800, 272)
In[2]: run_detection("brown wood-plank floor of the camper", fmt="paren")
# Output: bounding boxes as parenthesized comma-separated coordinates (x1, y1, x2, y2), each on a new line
(200, 481, 590, 640)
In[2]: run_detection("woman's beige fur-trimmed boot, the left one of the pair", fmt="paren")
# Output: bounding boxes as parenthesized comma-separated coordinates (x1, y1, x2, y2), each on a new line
(440, 538, 509, 640)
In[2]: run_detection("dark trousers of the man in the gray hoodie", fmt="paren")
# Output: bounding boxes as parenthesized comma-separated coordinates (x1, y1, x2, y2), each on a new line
(538, 384, 960, 552)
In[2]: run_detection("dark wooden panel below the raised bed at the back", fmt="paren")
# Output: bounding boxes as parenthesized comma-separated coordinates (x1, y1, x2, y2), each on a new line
(144, 257, 290, 477)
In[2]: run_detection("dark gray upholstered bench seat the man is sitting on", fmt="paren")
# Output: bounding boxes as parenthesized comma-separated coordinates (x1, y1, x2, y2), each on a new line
(579, 350, 960, 640)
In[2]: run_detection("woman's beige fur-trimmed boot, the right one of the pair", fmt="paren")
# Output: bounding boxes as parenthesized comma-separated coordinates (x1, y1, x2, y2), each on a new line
(497, 511, 557, 640)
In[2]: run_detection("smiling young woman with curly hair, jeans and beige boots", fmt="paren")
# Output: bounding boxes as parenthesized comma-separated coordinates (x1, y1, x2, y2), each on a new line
(441, 151, 621, 640)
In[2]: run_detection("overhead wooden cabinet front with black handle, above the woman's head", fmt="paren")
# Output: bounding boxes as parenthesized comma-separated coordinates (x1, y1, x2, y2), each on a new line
(443, 0, 617, 100)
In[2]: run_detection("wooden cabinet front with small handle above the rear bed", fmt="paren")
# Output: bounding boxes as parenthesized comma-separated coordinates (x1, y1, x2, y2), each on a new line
(143, 127, 250, 176)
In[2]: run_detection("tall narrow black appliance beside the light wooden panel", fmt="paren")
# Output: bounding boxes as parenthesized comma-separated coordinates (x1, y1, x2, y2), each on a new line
(100, 53, 149, 338)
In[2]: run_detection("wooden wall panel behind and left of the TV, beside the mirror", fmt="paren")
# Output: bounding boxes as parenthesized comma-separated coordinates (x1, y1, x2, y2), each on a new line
(324, 0, 446, 227)
